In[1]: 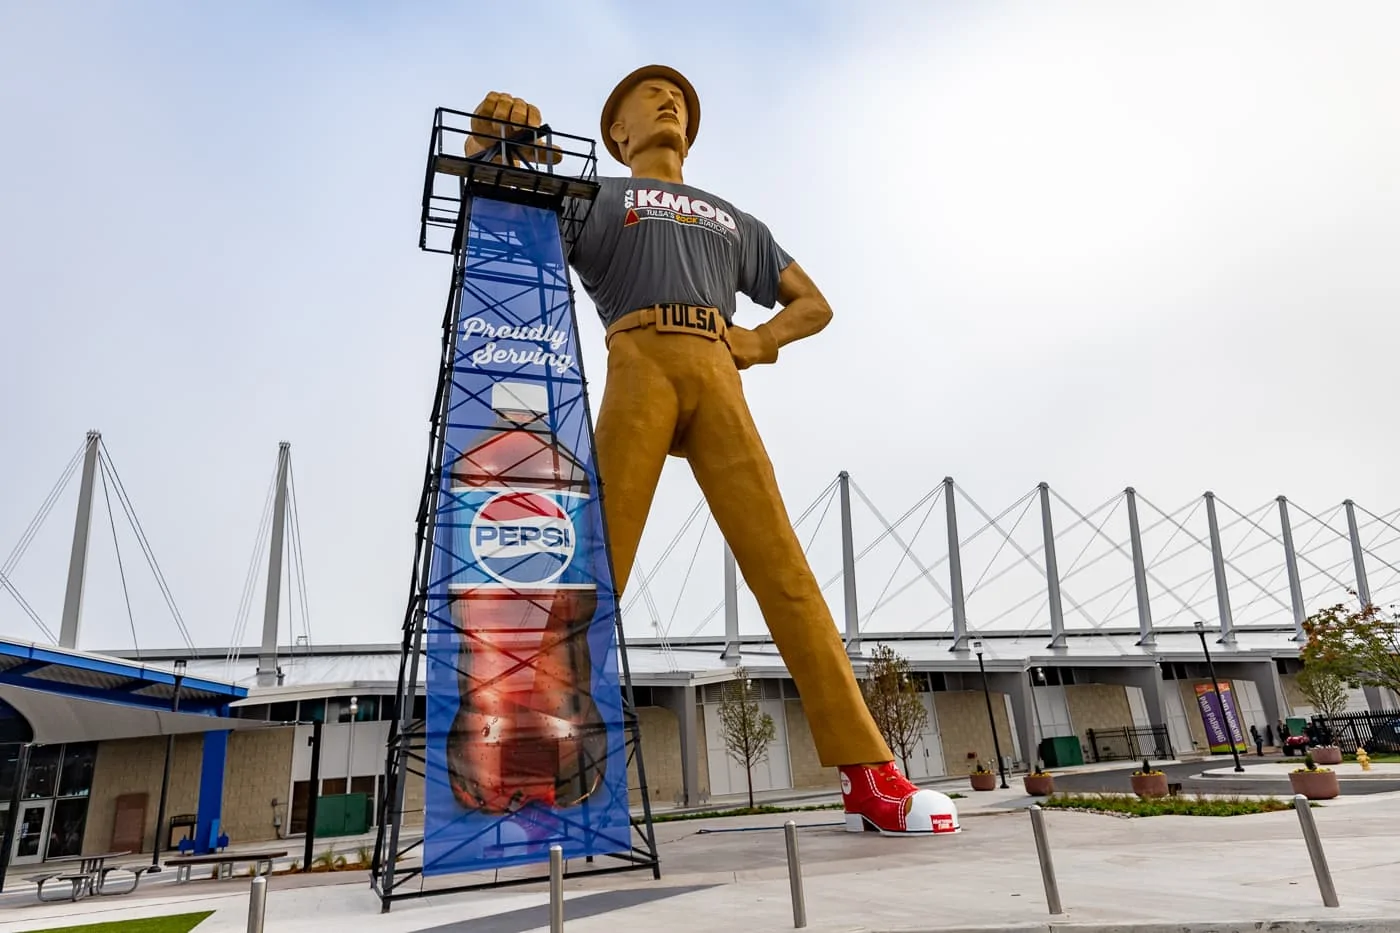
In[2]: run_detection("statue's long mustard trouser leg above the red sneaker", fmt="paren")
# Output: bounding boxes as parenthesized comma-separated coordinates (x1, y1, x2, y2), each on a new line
(682, 353, 893, 768)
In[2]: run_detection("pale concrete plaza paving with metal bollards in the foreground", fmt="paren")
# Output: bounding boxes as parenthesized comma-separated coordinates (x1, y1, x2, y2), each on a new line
(0, 782, 1400, 933)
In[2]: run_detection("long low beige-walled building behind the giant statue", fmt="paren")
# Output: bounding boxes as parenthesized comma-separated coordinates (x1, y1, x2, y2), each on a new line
(0, 622, 1369, 857)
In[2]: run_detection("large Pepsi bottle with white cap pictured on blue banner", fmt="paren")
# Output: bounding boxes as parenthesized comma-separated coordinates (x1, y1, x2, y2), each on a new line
(447, 382, 608, 814)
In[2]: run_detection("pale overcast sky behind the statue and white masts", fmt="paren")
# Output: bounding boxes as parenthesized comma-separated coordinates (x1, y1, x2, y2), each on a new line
(0, 0, 1400, 649)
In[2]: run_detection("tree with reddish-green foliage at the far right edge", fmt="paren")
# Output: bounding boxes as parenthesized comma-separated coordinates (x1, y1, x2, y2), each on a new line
(1302, 604, 1400, 692)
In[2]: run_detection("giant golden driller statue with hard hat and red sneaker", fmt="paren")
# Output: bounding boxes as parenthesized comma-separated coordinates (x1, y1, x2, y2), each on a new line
(466, 64, 958, 834)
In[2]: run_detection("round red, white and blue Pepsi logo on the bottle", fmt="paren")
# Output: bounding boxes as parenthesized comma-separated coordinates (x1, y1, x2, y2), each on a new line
(470, 492, 575, 586)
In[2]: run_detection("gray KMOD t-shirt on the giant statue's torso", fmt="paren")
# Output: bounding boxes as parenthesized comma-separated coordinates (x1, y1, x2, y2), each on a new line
(568, 178, 792, 326)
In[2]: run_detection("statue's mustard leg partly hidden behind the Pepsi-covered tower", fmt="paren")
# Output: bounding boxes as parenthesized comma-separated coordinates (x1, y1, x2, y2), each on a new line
(594, 331, 679, 595)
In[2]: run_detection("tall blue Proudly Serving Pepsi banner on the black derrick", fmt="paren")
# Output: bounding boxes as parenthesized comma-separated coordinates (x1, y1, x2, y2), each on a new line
(423, 198, 630, 876)
